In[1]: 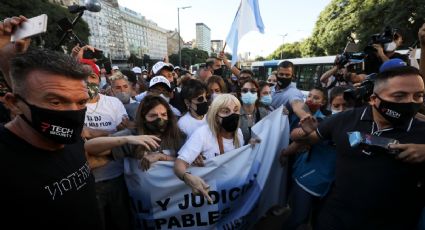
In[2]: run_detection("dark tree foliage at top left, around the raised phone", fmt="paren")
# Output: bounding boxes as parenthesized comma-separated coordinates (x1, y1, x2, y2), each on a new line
(0, 0, 90, 50)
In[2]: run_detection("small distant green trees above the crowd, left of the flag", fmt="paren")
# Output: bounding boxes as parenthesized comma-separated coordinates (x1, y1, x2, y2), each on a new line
(168, 48, 208, 68)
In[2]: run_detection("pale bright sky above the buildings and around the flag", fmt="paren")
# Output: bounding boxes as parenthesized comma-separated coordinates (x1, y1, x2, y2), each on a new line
(118, 0, 331, 58)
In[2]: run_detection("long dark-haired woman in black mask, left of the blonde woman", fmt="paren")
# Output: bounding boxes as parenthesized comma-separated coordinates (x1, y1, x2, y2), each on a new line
(85, 95, 185, 170)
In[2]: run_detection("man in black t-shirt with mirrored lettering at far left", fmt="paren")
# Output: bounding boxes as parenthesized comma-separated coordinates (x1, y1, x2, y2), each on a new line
(0, 17, 101, 229)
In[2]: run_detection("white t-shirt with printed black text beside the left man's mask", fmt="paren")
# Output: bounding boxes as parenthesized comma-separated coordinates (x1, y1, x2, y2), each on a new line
(84, 94, 127, 132)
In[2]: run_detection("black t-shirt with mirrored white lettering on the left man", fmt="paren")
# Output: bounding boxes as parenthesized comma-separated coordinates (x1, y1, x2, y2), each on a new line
(0, 125, 100, 229)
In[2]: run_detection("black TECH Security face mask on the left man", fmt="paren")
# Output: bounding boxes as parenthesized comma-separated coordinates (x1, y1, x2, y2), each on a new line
(16, 95, 86, 144)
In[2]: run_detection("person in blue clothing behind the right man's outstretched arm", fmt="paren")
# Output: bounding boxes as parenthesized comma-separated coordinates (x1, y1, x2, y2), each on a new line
(280, 86, 345, 230)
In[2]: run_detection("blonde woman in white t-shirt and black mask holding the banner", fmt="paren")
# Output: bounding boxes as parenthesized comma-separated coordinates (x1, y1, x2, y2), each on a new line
(174, 94, 243, 201)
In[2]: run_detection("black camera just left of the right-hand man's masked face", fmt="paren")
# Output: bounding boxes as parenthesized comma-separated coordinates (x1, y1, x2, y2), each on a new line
(344, 73, 377, 107)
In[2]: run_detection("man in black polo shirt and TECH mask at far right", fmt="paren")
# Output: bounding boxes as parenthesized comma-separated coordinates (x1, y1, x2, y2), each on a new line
(298, 66, 425, 230)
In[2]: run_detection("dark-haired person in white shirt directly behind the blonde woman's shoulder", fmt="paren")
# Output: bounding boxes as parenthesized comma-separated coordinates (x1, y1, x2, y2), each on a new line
(177, 79, 209, 137)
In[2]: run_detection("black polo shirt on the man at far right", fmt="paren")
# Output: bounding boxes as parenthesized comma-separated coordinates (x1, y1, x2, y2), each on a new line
(317, 106, 425, 230)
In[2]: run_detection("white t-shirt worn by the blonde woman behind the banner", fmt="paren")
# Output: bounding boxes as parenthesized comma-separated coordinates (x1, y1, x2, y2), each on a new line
(178, 125, 243, 164)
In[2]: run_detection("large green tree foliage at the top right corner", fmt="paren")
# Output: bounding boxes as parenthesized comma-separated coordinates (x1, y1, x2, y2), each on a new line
(268, 0, 425, 58)
